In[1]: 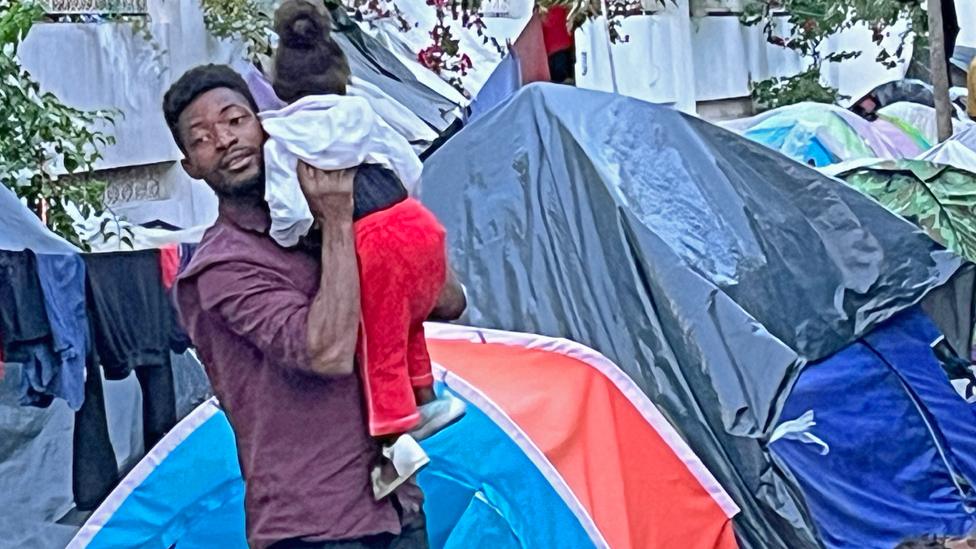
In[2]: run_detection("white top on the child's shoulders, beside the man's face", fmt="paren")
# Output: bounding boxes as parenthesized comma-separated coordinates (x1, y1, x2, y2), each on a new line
(260, 95, 423, 246)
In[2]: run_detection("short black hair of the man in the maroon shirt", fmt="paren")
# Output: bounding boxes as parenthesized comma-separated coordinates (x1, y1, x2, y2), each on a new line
(163, 65, 258, 152)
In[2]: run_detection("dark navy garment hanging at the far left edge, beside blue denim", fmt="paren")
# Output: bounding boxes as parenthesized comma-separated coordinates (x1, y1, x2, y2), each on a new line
(0, 251, 67, 409)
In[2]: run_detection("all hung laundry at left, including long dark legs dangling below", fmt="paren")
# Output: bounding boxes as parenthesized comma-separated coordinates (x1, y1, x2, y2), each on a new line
(0, 238, 202, 510)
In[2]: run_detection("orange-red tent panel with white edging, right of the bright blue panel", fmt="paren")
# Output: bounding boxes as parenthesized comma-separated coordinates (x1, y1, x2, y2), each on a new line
(428, 331, 737, 549)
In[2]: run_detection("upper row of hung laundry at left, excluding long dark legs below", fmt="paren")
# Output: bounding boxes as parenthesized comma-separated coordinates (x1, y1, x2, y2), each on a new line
(0, 244, 195, 410)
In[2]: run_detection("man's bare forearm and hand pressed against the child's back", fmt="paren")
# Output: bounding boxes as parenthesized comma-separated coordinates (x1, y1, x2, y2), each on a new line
(298, 163, 361, 376)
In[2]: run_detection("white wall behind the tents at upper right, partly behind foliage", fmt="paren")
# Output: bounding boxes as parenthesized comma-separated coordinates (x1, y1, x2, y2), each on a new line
(576, 8, 912, 112)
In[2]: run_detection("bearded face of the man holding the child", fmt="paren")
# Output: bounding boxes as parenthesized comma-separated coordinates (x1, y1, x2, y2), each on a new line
(177, 88, 265, 196)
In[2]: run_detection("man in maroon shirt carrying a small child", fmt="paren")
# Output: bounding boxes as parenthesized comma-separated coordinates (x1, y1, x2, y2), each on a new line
(163, 65, 464, 548)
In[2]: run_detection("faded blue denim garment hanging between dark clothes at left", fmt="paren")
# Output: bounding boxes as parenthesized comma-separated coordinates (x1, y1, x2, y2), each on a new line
(37, 254, 90, 410)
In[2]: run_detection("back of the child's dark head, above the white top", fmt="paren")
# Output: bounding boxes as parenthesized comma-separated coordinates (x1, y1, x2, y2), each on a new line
(273, 0, 350, 103)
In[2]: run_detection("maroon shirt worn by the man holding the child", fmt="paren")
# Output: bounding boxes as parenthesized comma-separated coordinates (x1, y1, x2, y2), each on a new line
(175, 199, 400, 547)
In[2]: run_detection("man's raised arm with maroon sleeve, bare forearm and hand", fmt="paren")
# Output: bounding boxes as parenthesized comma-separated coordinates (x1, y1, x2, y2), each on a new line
(197, 168, 360, 376)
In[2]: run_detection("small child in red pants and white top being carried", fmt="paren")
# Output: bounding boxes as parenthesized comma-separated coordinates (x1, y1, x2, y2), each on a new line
(261, 0, 464, 499)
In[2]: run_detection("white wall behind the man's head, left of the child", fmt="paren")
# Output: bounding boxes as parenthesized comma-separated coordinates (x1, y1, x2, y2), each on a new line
(18, 0, 240, 226)
